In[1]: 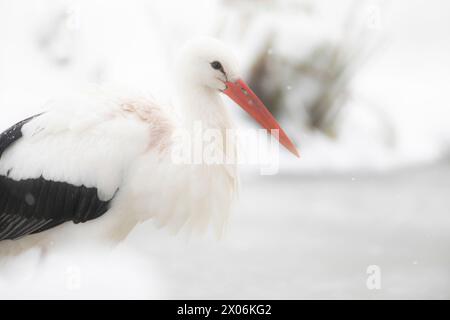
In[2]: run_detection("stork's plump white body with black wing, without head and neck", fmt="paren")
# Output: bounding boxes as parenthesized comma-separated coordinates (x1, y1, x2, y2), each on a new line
(0, 92, 237, 252)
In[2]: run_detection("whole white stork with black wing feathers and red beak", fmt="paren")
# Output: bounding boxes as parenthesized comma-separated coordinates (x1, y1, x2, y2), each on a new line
(0, 38, 298, 258)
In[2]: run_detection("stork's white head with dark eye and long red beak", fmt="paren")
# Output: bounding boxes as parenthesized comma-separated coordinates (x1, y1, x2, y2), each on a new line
(177, 38, 299, 157)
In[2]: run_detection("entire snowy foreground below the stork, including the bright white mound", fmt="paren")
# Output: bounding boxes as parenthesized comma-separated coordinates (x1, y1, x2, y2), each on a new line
(0, 163, 450, 299)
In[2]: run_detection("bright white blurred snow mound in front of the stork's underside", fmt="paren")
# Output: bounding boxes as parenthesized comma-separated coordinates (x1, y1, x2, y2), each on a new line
(0, 245, 165, 299)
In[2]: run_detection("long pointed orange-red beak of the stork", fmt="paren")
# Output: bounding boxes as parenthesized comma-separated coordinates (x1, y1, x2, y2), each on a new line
(223, 80, 300, 157)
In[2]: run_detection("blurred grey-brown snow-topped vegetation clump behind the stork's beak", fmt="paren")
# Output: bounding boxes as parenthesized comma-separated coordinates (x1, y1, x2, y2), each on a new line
(218, 0, 376, 137)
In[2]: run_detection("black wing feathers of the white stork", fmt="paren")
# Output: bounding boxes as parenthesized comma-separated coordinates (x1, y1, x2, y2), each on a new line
(0, 115, 112, 241)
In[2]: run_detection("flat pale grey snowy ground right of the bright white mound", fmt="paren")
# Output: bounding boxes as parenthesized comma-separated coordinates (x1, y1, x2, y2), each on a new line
(130, 164, 450, 299)
